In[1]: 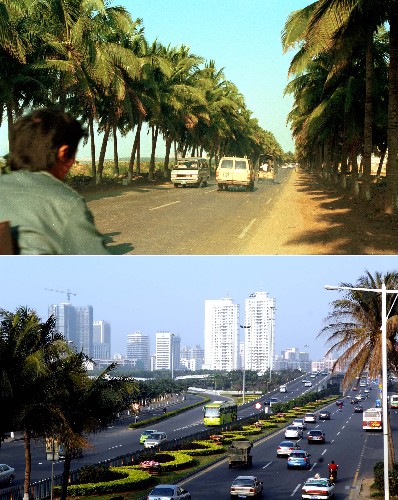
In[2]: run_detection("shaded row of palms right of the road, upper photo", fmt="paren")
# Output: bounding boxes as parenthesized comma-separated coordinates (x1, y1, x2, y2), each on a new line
(282, 0, 398, 213)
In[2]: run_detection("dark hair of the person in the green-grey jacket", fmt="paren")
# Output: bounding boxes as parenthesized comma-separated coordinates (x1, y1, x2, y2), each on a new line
(7, 108, 87, 172)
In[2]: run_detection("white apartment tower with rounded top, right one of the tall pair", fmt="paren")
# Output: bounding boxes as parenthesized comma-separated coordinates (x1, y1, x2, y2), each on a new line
(243, 292, 275, 372)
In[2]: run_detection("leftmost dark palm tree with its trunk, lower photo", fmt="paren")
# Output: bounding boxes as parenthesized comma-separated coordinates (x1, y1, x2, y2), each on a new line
(0, 307, 66, 500)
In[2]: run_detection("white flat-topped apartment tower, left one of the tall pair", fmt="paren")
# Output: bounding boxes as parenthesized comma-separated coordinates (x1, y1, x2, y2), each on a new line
(204, 298, 239, 371)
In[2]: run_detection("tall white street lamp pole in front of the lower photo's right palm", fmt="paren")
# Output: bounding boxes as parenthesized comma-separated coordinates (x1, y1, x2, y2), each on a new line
(325, 283, 398, 500)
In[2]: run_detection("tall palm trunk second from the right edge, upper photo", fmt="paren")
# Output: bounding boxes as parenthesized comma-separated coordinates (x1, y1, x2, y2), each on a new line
(361, 31, 373, 201)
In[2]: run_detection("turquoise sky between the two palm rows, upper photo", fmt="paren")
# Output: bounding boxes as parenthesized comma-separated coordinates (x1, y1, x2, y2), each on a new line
(0, 0, 311, 158)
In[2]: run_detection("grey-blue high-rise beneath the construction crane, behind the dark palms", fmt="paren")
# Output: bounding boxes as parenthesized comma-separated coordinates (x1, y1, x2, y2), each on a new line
(48, 303, 93, 357)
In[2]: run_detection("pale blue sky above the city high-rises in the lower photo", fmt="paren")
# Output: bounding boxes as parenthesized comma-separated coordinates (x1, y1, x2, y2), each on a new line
(0, 256, 398, 359)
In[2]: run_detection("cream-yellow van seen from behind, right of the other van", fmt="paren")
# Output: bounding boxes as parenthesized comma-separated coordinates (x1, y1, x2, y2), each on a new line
(216, 156, 255, 191)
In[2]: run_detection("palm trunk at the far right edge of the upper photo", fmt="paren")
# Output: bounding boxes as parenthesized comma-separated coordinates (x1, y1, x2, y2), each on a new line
(386, 7, 398, 214)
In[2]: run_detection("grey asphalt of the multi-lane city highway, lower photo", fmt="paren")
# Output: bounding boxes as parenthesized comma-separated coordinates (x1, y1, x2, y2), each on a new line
(0, 377, 398, 500)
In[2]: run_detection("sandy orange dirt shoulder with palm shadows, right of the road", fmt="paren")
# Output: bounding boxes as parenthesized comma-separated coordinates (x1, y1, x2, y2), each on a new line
(247, 170, 398, 255)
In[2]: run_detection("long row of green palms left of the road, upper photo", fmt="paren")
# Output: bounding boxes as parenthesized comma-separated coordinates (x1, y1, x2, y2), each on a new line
(0, 0, 283, 181)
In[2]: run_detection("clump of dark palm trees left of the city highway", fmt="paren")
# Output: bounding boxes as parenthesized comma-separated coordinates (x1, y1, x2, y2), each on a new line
(0, 307, 182, 499)
